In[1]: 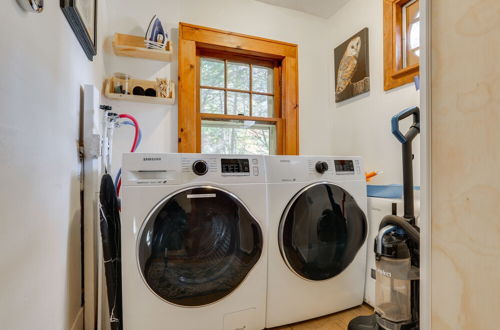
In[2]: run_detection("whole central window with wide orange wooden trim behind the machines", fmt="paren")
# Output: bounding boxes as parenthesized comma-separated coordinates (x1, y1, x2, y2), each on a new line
(179, 23, 298, 155)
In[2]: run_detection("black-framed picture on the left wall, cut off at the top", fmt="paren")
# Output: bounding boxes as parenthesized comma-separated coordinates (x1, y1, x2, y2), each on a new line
(60, 0, 97, 61)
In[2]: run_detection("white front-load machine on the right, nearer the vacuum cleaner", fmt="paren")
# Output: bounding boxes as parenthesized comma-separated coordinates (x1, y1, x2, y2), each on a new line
(266, 156, 368, 328)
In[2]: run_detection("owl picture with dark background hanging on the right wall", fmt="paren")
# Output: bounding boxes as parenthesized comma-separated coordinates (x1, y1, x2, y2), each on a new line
(334, 28, 370, 103)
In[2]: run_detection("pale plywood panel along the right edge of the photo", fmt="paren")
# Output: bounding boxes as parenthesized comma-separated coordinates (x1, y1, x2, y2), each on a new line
(431, 0, 500, 330)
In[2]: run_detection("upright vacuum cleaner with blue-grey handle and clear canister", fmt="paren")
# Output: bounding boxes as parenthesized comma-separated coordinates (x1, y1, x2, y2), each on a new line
(348, 107, 420, 330)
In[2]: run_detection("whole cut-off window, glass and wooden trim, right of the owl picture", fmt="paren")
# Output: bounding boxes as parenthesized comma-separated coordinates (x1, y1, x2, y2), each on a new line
(384, 0, 420, 90)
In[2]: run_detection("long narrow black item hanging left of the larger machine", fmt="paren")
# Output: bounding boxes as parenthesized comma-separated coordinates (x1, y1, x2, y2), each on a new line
(99, 174, 123, 330)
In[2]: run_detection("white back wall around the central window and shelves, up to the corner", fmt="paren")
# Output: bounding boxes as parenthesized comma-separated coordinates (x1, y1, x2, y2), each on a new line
(106, 0, 333, 175)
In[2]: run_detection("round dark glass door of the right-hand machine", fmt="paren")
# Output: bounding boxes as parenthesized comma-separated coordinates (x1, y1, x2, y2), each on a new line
(279, 183, 368, 281)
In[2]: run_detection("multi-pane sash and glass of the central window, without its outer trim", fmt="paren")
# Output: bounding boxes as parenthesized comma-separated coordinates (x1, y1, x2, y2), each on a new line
(200, 56, 278, 155)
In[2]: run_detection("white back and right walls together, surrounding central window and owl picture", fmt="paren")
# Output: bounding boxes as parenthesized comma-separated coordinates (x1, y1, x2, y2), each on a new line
(106, 0, 419, 184)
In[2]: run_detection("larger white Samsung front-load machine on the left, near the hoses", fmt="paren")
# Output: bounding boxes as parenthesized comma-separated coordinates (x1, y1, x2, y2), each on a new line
(121, 154, 267, 330)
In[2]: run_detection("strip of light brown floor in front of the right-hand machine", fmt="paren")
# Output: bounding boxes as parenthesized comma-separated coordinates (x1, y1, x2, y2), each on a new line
(272, 304, 373, 330)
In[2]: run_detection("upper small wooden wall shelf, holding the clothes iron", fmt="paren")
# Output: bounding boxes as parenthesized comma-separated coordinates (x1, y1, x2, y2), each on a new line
(113, 33, 173, 62)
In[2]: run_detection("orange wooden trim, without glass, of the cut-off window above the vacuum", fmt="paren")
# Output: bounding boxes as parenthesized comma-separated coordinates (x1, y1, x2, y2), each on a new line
(383, 0, 420, 91)
